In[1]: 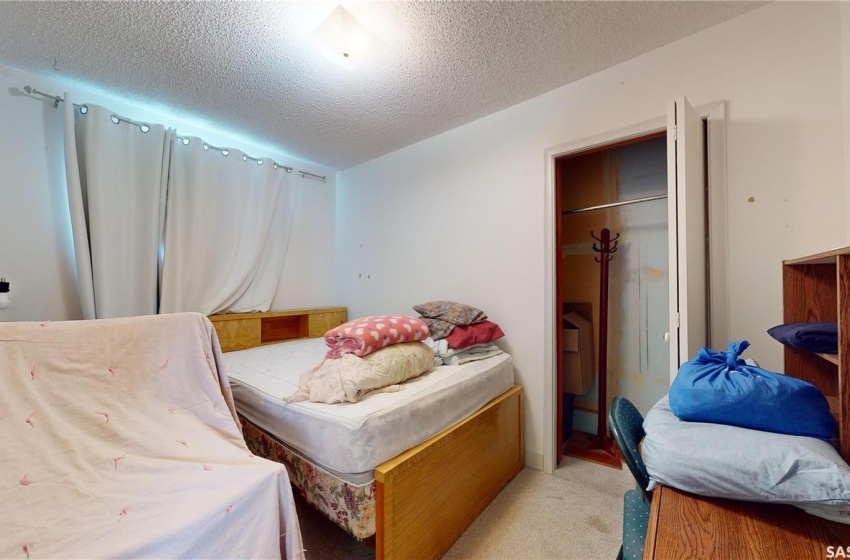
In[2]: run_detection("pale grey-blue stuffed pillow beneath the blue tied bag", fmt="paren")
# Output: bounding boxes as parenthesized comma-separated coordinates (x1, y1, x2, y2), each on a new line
(641, 396, 850, 510)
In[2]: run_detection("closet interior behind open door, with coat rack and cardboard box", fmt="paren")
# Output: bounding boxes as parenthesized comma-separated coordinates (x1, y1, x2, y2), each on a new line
(554, 125, 709, 468)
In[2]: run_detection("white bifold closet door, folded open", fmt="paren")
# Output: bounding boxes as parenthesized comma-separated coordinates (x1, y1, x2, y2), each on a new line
(667, 97, 708, 380)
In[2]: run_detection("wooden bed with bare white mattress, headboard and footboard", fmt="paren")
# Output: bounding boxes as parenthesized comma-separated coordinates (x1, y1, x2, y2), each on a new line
(210, 308, 523, 558)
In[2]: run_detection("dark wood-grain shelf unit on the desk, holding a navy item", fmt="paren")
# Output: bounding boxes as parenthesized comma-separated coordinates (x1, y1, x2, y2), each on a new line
(782, 247, 850, 462)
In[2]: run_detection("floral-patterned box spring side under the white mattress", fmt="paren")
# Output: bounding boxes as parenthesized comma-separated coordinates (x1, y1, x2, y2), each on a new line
(239, 415, 376, 539)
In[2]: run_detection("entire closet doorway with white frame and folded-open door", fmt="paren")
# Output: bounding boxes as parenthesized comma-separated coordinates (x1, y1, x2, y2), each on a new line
(544, 96, 730, 473)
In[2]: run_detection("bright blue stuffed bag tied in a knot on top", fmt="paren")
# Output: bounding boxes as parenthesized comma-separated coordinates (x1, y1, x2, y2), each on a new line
(670, 340, 835, 440)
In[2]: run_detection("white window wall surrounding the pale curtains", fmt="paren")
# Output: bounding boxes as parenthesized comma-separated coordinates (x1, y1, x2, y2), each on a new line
(0, 61, 335, 321)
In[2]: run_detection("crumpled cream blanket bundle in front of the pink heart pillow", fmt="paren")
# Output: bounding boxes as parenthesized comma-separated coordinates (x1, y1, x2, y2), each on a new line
(284, 342, 434, 404)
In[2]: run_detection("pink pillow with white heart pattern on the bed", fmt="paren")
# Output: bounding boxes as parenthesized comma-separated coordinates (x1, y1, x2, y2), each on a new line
(325, 315, 428, 358)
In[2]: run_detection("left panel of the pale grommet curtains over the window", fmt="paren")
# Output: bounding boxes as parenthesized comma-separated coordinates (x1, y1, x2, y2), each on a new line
(65, 96, 173, 319)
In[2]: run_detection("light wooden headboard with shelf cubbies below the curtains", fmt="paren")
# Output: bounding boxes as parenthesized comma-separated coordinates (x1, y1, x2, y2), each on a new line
(209, 307, 348, 352)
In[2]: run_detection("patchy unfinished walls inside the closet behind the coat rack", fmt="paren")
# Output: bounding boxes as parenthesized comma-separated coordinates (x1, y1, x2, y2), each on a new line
(558, 136, 669, 434)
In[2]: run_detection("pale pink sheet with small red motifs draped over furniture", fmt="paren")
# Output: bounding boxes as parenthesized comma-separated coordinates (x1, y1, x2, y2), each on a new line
(0, 313, 303, 558)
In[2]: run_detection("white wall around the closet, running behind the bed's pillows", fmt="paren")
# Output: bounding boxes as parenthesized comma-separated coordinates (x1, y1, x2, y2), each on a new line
(336, 2, 848, 466)
